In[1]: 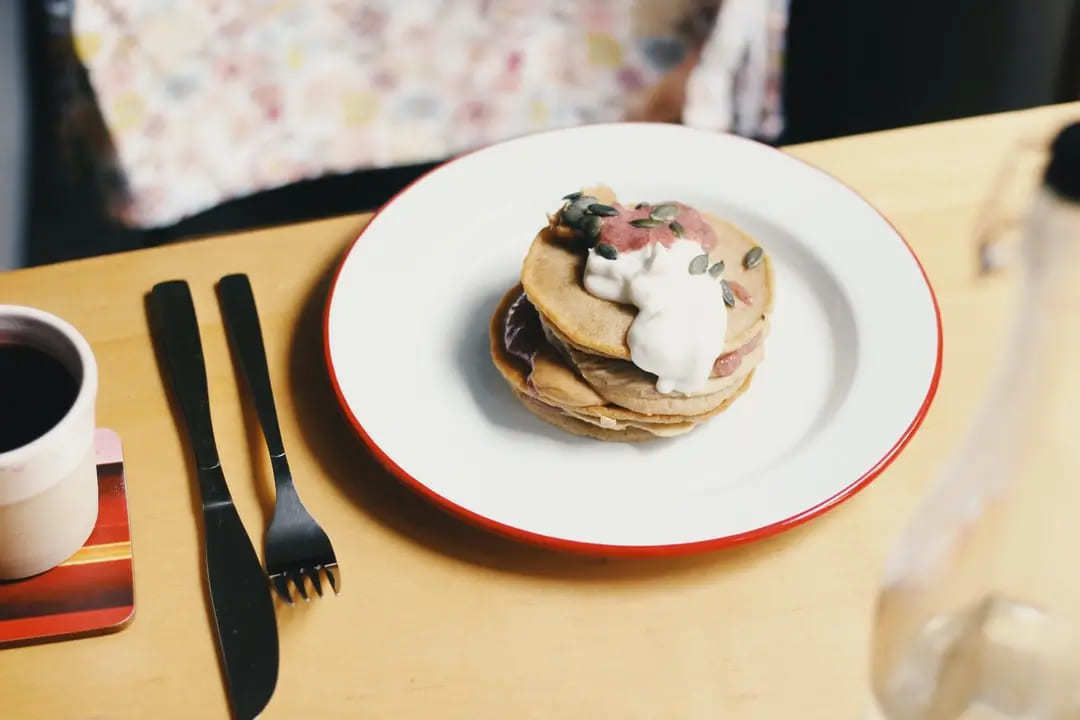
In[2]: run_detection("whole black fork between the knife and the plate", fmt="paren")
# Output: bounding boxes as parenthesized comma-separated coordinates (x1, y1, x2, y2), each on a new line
(217, 274, 341, 604)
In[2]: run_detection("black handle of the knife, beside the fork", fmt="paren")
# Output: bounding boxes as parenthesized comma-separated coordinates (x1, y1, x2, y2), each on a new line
(150, 280, 230, 507)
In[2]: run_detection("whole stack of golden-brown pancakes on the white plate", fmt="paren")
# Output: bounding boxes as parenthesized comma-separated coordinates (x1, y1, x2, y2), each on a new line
(490, 188, 773, 441)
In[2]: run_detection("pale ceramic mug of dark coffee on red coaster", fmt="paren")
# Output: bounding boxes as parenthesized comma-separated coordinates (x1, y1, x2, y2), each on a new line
(0, 304, 97, 580)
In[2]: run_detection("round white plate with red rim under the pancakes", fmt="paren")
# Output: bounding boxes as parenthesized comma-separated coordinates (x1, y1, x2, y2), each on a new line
(325, 124, 941, 554)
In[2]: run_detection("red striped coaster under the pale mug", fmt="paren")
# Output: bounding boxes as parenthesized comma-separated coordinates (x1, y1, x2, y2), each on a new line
(0, 430, 135, 644)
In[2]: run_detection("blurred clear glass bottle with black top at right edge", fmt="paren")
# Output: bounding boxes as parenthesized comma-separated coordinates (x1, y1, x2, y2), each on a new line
(872, 124, 1080, 720)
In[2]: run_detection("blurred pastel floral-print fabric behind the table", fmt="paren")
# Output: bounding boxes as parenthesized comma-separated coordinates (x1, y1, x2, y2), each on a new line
(73, 0, 786, 227)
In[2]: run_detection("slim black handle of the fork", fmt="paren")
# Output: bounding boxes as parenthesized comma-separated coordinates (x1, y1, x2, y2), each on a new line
(217, 273, 285, 459)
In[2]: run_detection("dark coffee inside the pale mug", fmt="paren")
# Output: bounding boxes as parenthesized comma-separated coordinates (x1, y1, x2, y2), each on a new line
(0, 341, 79, 452)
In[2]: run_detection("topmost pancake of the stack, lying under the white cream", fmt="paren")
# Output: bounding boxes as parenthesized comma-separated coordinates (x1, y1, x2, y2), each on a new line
(522, 209, 773, 361)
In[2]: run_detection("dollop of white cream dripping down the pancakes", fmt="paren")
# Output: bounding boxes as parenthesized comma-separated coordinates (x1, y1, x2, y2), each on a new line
(584, 235, 728, 394)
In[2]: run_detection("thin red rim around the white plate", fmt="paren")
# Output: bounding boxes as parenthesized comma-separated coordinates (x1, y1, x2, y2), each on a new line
(323, 123, 944, 557)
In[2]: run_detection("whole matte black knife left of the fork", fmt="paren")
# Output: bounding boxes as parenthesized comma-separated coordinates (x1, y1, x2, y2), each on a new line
(150, 280, 278, 720)
